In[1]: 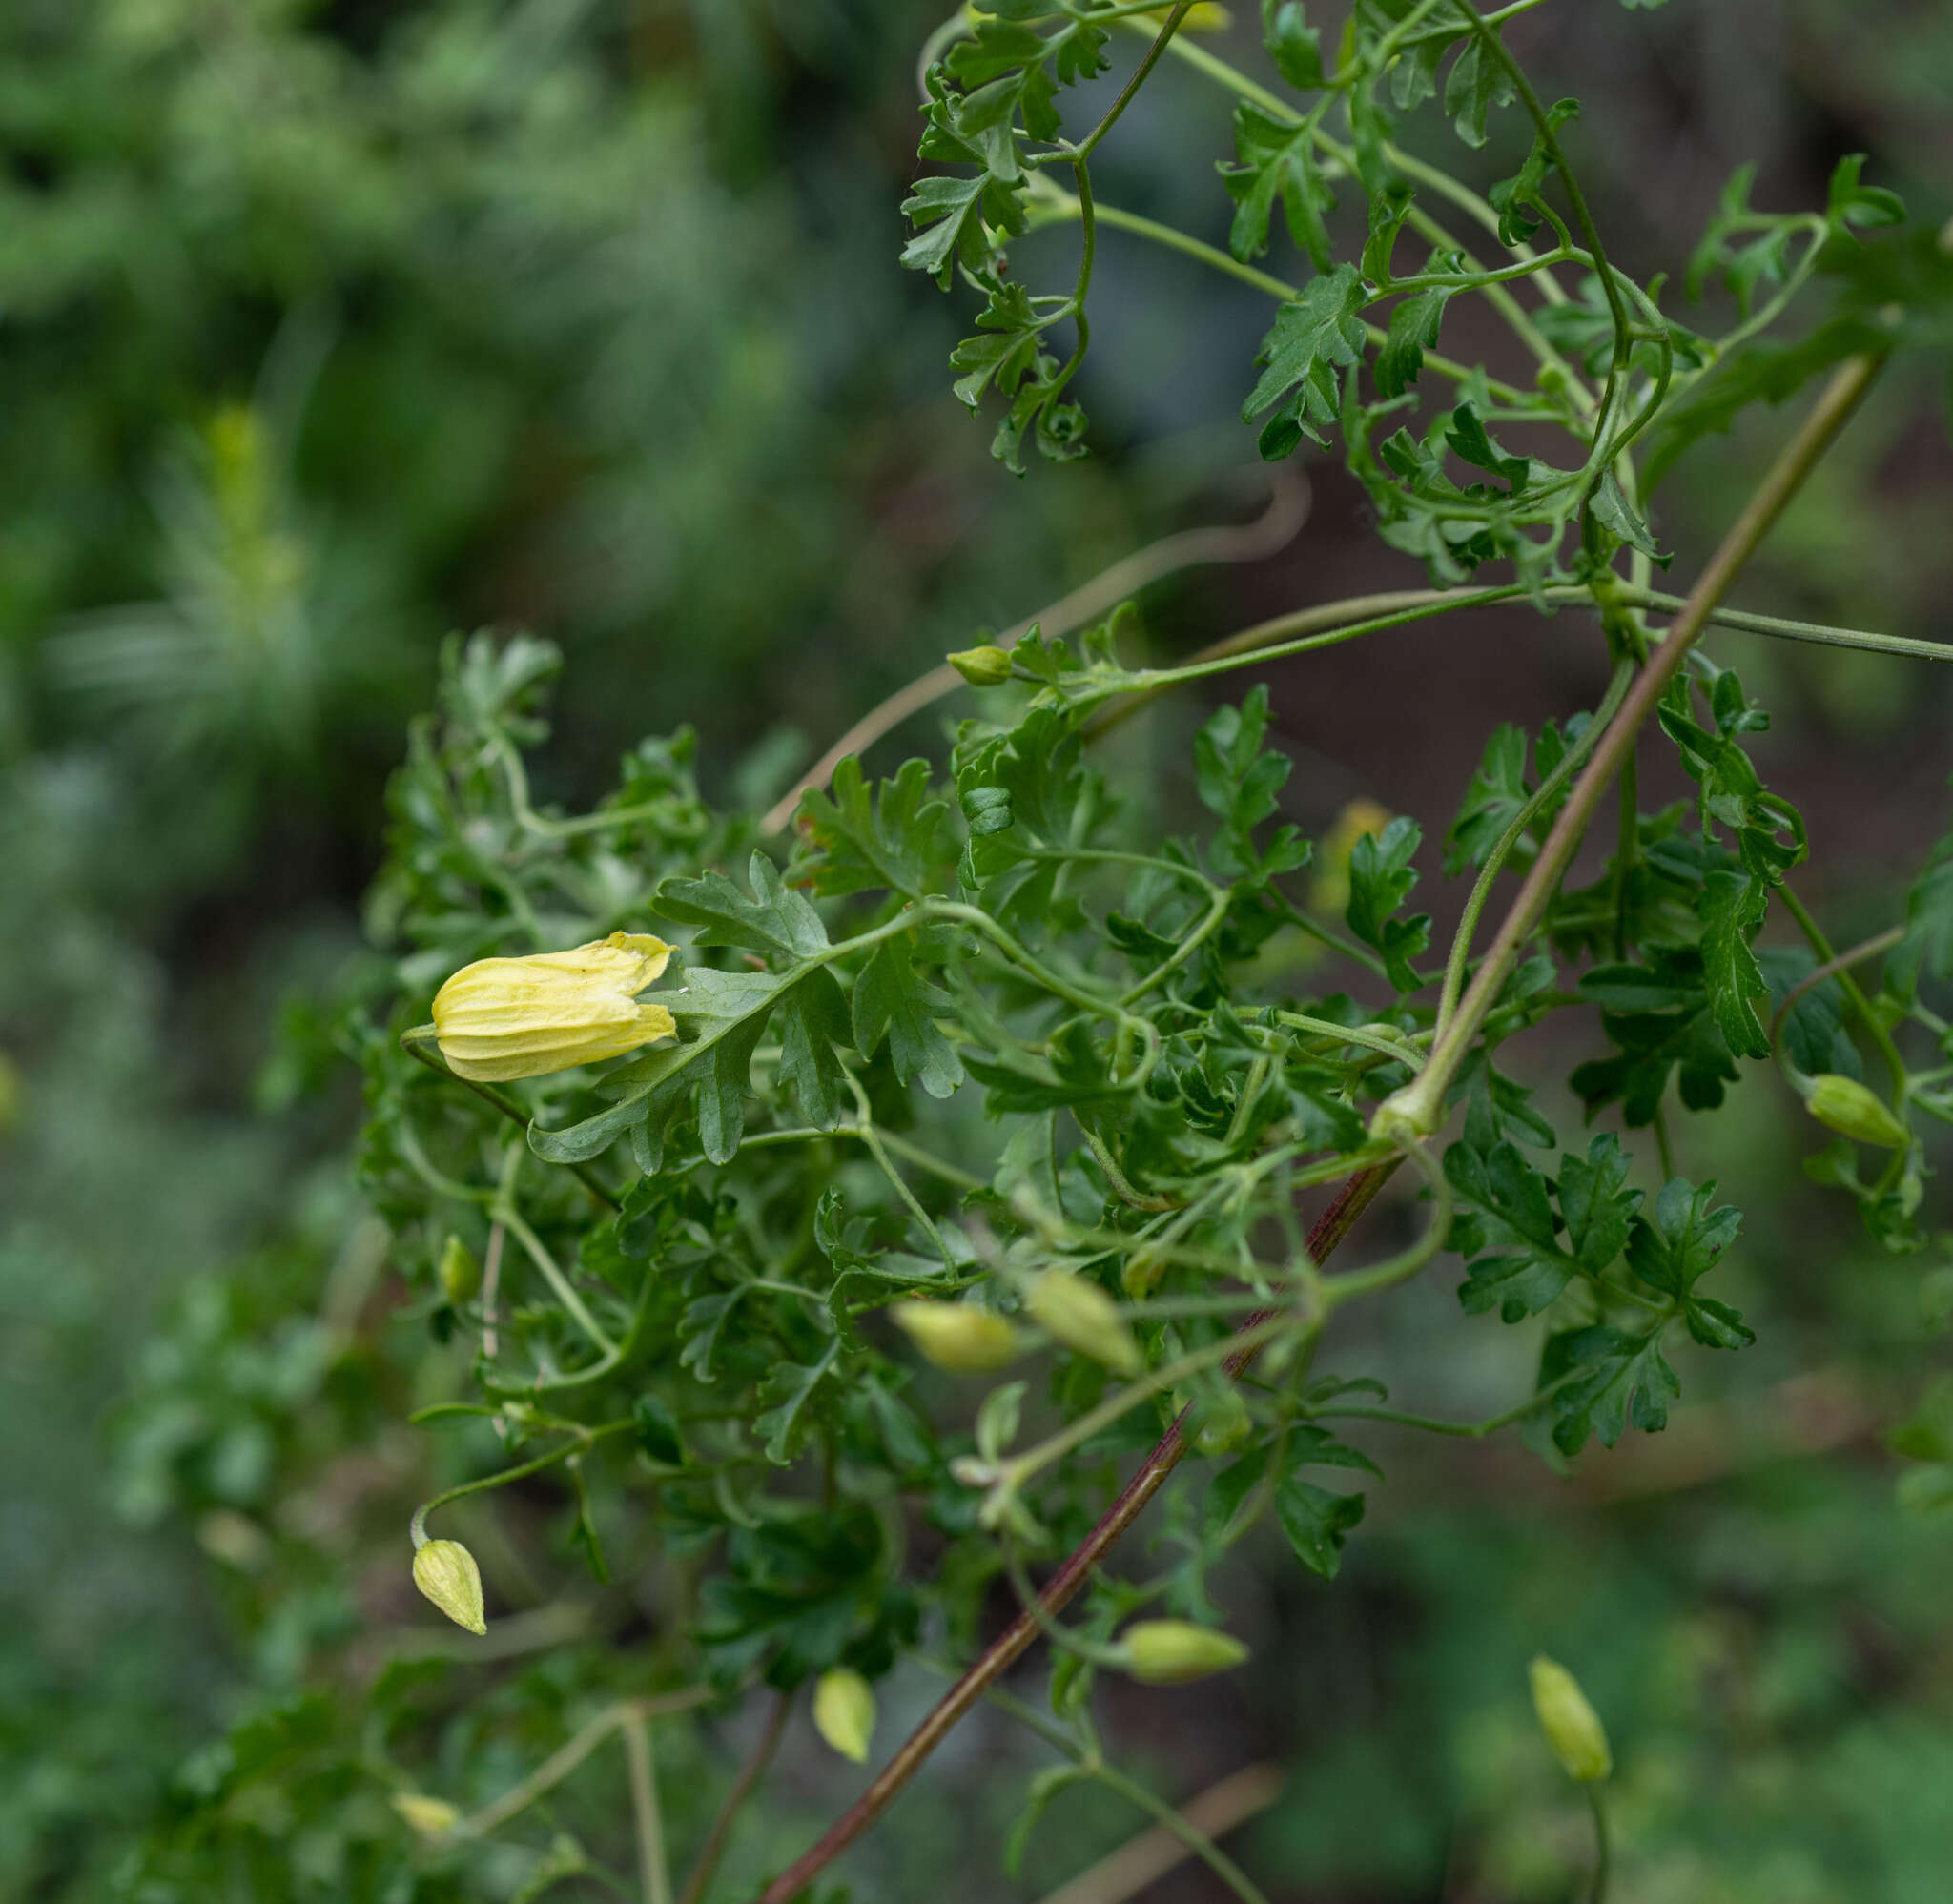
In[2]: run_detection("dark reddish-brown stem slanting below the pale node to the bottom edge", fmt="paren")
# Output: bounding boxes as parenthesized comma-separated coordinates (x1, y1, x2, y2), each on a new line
(760, 1158, 1396, 1904)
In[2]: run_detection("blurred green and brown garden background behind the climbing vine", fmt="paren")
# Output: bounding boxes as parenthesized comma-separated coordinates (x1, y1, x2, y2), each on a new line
(0, 0, 1953, 1904)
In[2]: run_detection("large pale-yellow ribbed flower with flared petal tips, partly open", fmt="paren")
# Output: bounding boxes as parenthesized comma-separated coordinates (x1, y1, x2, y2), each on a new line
(434, 932, 678, 1084)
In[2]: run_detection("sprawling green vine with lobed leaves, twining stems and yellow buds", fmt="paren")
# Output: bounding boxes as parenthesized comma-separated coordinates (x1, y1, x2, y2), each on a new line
(92, 0, 1953, 1904)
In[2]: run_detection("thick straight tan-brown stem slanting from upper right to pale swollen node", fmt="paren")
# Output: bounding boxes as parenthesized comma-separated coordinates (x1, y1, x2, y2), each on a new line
(1377, 358, 1882, 1136)
